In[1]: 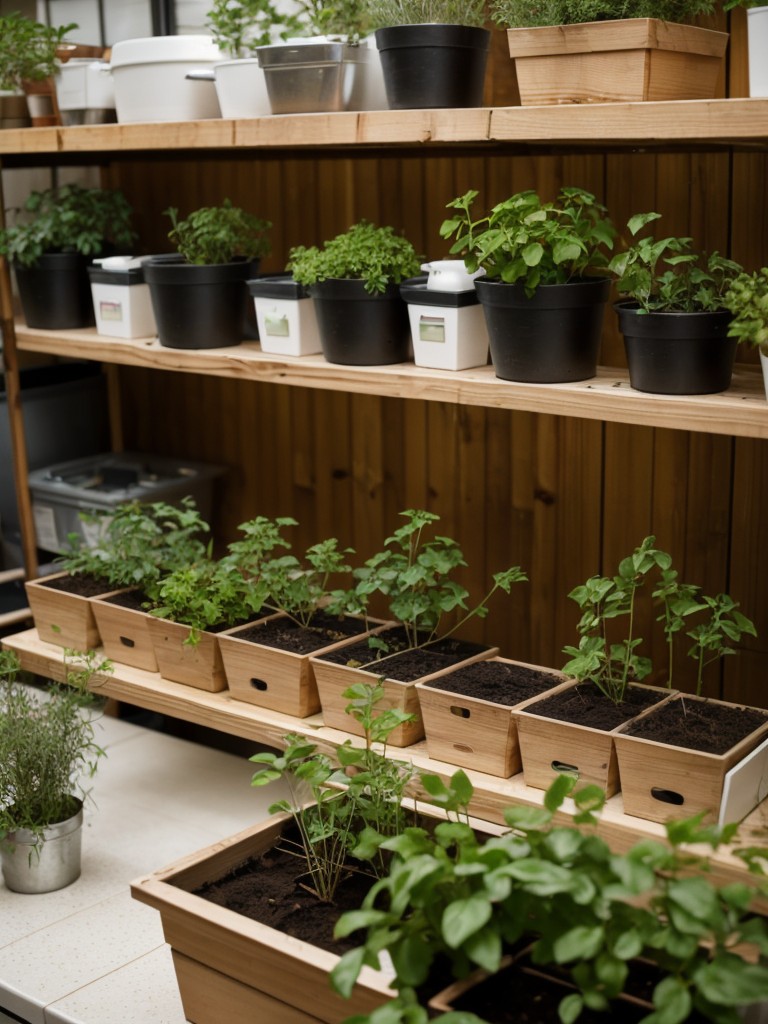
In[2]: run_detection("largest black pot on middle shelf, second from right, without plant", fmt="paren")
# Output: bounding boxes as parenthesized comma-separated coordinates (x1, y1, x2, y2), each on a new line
(475, 278, 610, 384)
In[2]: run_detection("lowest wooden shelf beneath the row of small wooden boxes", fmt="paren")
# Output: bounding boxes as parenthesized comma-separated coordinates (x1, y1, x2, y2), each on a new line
(2, 629, 768, 911)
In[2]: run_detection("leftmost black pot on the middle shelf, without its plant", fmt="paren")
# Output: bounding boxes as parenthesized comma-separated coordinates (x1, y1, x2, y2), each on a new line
(14, 253, 96, 331)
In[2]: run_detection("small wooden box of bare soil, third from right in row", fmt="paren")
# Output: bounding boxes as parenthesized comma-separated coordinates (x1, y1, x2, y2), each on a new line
(416, 657, 565, 778)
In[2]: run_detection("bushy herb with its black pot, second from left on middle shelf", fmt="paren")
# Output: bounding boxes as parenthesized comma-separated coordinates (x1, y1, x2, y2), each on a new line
(144, 199, 271, 348)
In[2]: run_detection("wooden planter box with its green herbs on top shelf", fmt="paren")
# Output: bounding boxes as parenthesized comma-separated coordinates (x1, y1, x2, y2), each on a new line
(492, 0, 728, 104)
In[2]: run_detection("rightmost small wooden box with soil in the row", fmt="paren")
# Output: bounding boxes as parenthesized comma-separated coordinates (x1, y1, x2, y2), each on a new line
(614, 693, 768, 821)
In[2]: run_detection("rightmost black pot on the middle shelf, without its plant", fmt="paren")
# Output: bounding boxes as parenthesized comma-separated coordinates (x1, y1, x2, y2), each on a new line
(613, 302, 737, 394)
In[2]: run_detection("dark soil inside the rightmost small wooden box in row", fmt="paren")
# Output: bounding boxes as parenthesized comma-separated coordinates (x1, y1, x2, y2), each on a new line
(626, 697, 768, 754)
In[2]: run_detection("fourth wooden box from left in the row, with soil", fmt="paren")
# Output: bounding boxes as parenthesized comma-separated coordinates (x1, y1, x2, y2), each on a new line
(219, 614, 391, 718)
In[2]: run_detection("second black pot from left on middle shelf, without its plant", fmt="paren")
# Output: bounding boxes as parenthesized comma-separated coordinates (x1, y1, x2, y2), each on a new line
(144, 254, 258, 348)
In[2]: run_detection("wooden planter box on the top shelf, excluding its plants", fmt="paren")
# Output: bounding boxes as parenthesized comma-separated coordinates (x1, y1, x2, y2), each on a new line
(507, 17, 728, 106)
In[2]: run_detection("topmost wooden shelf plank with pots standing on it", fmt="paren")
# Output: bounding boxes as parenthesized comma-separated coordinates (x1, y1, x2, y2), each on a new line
(0, 98, 768, 156)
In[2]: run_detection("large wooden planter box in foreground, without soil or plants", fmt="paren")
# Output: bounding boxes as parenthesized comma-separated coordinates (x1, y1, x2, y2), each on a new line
(131, 815, 394, 1024)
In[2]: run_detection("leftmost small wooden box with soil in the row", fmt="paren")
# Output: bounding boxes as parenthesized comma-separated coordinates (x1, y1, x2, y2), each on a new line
(25, 572, 117, 652)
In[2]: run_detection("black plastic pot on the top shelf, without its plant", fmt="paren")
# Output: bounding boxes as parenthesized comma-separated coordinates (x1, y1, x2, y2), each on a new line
(376, 25, 490, 111)
